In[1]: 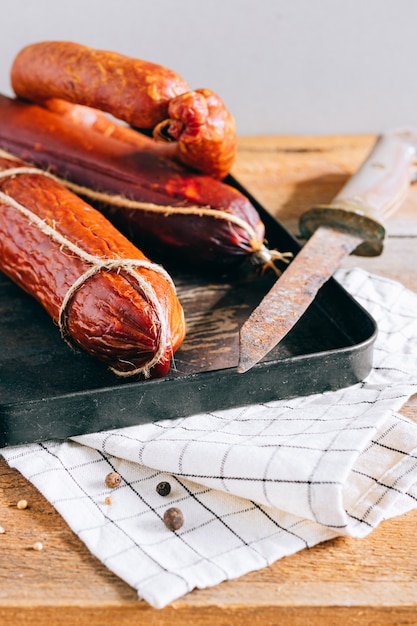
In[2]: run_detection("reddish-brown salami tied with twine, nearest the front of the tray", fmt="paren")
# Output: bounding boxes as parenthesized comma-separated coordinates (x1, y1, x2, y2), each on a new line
(0, 153, 185, 377)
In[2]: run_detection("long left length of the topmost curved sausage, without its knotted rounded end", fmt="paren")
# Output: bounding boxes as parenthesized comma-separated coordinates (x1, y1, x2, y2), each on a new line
(10, 41, 190, 128)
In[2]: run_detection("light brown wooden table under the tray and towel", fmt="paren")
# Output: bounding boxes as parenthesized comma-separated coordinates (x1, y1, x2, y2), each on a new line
(0, 135, 417, 626)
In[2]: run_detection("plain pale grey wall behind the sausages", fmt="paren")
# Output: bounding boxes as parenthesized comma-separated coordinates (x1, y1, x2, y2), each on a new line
(0, 0, 417, 135)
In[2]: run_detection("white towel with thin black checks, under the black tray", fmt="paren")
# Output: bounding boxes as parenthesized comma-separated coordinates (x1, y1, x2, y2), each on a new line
(3, 270, 417, 607)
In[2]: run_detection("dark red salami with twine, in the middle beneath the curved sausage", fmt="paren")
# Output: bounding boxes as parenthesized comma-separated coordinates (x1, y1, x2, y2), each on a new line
(0, 96, 285, 271)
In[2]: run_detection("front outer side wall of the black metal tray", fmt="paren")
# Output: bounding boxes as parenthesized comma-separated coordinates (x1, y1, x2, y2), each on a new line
(0, 324, 377, 448)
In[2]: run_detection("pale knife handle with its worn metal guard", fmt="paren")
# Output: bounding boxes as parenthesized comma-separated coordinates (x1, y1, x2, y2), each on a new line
(300, 129, 417, 256)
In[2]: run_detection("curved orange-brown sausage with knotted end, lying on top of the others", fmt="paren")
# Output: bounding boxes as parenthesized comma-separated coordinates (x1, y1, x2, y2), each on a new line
(11, 41, 237, 179)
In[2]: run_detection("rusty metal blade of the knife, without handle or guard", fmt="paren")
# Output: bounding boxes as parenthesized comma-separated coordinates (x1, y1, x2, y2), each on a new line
(237, 226, 362, 373)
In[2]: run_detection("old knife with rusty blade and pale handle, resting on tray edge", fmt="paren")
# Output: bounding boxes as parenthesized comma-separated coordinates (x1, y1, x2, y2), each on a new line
(237, 128, 417, 373)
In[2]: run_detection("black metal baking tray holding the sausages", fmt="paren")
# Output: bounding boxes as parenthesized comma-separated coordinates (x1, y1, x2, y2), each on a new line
(0, 177, 377, 447)
